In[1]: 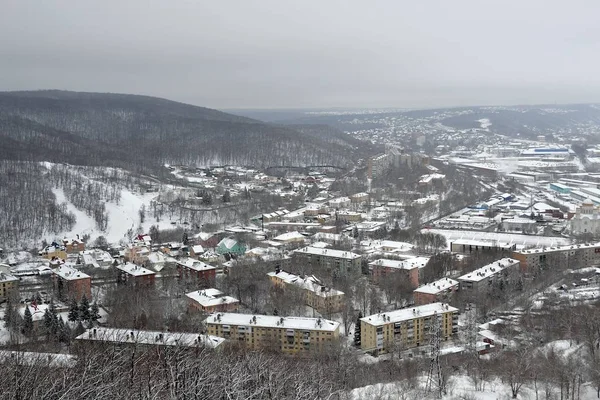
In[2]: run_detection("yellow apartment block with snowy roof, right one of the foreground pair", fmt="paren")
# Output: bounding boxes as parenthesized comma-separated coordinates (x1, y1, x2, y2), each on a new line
(360, 303, 458, 353)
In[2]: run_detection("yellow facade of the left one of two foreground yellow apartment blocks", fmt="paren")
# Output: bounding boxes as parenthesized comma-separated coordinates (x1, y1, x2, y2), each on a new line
(207, 322, 339, 354)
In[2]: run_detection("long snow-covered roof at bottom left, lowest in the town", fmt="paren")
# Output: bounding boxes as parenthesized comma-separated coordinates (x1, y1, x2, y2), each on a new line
(75, 328, 225, 348)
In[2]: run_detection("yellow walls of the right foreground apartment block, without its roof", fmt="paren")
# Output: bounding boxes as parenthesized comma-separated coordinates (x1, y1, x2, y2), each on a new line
(360, 311, 458, 353)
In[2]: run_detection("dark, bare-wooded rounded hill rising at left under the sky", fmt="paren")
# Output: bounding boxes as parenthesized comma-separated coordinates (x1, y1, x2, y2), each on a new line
(0, 90, 360, 170)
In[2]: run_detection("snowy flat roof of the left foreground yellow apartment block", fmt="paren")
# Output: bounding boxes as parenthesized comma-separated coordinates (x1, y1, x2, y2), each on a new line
(204, 313, 340, 332)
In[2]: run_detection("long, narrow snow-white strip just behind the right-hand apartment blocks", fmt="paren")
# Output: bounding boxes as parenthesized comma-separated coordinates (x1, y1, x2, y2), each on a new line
(422, 229, 571, 249)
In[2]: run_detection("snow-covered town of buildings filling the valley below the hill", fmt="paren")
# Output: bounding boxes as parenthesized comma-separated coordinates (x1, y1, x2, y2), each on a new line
(0, 136, 600, 398)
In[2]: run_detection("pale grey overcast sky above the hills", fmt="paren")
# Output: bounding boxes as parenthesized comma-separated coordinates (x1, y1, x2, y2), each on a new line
(0, 0, 600, 109)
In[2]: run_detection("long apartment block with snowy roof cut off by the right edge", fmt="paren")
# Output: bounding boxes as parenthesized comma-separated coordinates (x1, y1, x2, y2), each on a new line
(512, 242, 600, 272)
